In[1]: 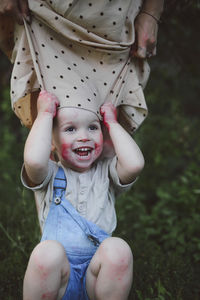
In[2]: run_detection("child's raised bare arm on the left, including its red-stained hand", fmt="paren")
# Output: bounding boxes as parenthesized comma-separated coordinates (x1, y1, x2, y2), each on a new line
(24, 91, 59, 185)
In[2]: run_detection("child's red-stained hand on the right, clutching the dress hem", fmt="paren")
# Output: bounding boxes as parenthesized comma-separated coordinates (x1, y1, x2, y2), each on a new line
(100, 102, 117, 129)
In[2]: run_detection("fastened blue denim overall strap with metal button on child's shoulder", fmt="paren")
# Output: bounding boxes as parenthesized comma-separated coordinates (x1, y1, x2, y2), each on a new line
(53, 167, 67, 204)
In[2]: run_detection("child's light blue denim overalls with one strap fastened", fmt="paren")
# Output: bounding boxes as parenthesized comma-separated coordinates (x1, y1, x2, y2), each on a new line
(41, 167, 109, 300)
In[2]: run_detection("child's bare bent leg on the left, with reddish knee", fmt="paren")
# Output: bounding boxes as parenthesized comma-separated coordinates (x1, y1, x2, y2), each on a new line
(23, 241, 70, 300)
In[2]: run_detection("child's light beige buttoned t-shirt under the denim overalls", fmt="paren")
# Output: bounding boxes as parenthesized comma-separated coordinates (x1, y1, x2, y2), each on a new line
(21, 157, 133, 235)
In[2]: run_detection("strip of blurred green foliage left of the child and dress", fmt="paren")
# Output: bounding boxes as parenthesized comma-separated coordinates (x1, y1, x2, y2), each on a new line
(0, 82, 39, 300)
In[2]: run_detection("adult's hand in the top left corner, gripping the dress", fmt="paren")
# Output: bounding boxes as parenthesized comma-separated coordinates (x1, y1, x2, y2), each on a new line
(0, 0, 31, 25)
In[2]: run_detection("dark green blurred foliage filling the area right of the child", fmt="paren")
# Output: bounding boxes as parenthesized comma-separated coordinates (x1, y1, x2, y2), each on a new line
(116, 1, 200, 300)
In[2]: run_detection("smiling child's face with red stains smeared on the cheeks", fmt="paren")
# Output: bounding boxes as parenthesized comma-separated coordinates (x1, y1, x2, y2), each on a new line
(53, 107, 103, 172)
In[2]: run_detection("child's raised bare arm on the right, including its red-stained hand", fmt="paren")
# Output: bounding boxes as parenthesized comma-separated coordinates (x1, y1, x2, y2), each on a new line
(101, 103, 144, 184)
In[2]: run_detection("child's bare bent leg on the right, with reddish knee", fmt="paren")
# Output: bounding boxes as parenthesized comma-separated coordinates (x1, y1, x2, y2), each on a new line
(86, 237, 133, 300)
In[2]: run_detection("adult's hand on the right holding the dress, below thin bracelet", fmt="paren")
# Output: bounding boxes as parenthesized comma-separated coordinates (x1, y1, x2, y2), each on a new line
(131, 12, 158, 58)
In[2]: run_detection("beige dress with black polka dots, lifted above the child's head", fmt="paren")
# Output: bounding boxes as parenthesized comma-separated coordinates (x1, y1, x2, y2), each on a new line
(1, 0, 149, 133)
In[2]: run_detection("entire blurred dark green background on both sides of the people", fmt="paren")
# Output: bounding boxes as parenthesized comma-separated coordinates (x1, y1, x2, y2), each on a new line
(0, 0, 200, 300)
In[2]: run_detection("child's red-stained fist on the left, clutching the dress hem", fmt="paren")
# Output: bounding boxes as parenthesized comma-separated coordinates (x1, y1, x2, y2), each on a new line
(37, 90, 59, 117)
